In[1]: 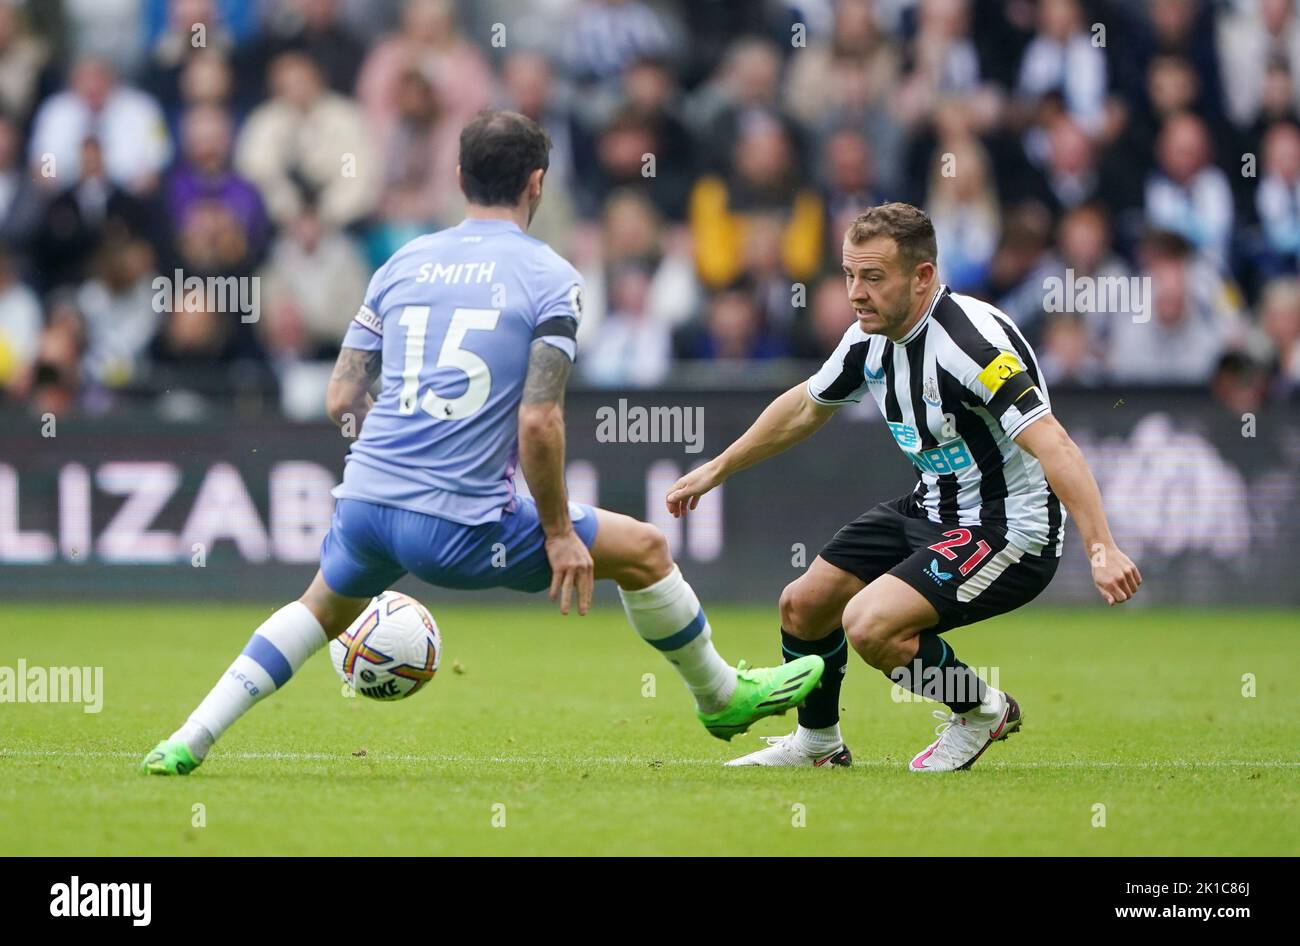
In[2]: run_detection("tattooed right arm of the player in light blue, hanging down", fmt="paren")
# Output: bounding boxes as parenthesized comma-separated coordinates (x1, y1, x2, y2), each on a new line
(519, 340, 594, 615)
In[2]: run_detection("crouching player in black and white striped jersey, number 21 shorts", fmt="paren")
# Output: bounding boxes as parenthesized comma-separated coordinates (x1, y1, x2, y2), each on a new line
(667, 203, 1141, 772)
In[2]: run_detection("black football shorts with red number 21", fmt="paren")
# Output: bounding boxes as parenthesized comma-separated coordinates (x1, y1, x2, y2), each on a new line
(822, 494, 1061, 633)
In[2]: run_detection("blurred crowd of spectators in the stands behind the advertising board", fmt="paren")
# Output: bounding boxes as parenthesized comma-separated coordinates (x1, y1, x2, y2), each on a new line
(0, 0, 1300, 416)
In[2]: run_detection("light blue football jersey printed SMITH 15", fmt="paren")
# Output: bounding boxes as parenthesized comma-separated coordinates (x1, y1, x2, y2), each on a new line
(334, 220, 582, 525)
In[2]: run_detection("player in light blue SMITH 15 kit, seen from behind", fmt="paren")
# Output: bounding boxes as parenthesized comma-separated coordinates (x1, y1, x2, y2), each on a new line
(142, 112, 824, 774)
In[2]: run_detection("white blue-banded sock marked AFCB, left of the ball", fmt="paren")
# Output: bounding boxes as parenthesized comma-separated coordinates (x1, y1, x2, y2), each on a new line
(172, 602, 326, 760)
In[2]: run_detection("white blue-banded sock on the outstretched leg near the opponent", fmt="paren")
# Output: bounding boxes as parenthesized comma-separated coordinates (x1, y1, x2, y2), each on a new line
(619, 565, 736, 713)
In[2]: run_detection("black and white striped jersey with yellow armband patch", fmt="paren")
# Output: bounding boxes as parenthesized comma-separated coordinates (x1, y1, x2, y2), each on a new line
(807, 286, 1065, 556)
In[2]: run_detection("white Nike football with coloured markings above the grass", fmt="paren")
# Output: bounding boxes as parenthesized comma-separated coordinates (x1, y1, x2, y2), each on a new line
(329, 591, 442, 700)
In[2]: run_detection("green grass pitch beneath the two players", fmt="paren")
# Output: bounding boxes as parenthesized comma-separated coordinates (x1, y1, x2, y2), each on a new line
(0, 605, 1300, 855)
